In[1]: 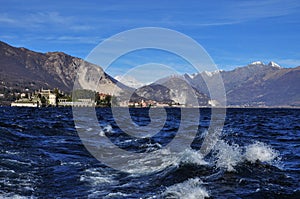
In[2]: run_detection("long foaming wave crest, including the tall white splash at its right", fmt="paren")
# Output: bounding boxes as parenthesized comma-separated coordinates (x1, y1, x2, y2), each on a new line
(89, 125, 280, 174)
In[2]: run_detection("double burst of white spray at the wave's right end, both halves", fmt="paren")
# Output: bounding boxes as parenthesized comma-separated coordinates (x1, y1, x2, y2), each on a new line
(214, 140, 279, 172)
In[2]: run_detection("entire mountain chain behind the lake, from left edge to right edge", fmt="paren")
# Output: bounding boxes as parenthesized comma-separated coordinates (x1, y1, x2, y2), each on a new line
(0, 42, 300, 106)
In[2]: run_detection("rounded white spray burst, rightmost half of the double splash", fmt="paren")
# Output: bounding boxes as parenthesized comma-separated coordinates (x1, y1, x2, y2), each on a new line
(245, 142, 279, 163)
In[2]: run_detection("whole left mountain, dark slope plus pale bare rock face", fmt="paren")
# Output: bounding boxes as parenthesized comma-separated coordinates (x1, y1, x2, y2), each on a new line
(0, 42, 130, 103)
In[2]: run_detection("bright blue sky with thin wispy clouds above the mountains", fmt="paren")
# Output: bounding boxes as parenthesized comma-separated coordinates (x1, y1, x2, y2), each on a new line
(0, 0, 300, 76)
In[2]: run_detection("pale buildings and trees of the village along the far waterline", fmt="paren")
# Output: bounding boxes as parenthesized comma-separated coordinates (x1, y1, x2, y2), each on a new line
(11, 89, 181, 107)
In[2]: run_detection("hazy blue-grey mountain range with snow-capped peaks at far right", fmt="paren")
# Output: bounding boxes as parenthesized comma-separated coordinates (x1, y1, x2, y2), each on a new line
(184, 61, 300, 106)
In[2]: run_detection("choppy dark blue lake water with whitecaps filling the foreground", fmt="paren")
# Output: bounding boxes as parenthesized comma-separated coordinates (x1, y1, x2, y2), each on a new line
(0, 107, 300, 199)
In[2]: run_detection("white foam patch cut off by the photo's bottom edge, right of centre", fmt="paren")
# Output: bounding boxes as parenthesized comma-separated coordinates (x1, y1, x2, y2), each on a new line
(161, 178, 209, 199)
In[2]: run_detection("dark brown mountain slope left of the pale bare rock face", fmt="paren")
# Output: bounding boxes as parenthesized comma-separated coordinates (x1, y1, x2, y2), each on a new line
(0, 42, 82, 92)
